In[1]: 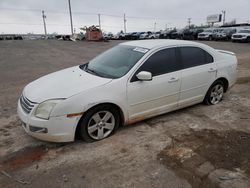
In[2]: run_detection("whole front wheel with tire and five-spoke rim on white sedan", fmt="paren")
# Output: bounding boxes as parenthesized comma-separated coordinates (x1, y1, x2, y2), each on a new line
(80, 105, 120, 142)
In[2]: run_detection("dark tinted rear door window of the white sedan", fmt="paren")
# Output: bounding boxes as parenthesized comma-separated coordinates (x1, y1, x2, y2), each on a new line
(180, 47, 213, 69)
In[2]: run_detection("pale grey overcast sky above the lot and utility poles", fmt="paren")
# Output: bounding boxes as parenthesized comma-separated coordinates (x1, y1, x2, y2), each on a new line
(0, 0, 250, 34)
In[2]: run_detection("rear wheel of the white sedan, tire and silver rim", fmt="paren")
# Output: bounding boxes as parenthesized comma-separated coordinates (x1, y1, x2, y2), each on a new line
(203, 80, 225, 105)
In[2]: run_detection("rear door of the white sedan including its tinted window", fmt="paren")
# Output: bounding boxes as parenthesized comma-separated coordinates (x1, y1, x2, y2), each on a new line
(178, 46, 217, 106)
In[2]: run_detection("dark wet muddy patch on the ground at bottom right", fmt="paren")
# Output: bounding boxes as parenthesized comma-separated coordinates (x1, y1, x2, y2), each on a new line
(158, 130, 250, 188)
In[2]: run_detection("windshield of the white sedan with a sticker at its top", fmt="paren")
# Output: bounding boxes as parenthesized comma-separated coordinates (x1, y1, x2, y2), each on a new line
(80, 45, 148, 78)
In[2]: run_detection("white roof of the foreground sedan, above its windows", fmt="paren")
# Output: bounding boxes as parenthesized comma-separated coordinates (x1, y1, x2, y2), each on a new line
(120, 39, 200, 49)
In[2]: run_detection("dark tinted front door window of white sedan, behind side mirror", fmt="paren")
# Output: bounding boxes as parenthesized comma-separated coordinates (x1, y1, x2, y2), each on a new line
(131, 48, 180, 82)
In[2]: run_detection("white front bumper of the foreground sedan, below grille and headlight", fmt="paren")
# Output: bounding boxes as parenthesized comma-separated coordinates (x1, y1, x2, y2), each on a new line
(17, 100, 80, 142)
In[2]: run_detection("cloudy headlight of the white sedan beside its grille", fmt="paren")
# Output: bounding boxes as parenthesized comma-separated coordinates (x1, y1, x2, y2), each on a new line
(35, 99, 63, 119)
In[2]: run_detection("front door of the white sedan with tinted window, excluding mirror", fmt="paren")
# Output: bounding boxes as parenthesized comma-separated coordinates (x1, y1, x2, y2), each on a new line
(127, 48, 181, 123)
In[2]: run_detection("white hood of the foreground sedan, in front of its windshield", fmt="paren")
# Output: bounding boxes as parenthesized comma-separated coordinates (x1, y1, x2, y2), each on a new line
(23, 66, 112, 103)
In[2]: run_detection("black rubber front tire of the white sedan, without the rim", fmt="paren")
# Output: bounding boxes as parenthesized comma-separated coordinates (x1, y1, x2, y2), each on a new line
(80, 105, 120, 142)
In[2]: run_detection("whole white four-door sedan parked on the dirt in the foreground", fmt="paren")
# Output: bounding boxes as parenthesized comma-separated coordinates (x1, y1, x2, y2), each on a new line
(18, 39, 237, 142)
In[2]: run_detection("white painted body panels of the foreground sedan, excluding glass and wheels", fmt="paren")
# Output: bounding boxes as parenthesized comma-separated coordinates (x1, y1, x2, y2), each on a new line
(17, 39, 237, 142)
